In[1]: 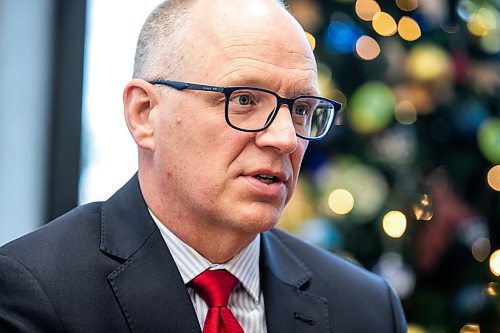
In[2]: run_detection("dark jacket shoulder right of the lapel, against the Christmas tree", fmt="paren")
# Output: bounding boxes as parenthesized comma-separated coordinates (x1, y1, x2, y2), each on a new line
(269, 229, 406, 332)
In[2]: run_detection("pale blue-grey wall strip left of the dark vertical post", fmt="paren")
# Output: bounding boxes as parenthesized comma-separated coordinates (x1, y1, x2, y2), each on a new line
(0, 0, 53, 245)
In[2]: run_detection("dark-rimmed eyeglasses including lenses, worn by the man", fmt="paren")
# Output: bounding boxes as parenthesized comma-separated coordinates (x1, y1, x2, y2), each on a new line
(149, 80, 342, 140)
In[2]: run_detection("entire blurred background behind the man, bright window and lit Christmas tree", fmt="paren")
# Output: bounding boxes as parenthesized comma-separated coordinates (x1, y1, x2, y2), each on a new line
(0, 0, 500, 333)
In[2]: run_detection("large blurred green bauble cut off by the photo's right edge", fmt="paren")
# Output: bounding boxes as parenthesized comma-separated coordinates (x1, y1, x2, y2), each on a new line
(477, 117, 500, 164)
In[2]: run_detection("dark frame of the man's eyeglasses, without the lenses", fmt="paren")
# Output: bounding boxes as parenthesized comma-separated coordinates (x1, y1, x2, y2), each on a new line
(148, 79, 342, 141)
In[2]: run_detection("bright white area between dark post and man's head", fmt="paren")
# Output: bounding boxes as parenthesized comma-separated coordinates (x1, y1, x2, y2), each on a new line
(79, 0, 161, 203)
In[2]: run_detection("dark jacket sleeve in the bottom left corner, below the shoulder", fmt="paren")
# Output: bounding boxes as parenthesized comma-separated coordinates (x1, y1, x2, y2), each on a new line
(0, 254, 64, 333)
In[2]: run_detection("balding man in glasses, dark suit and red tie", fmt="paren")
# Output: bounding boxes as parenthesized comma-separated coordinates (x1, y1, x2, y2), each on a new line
(0, 0, 406, 332)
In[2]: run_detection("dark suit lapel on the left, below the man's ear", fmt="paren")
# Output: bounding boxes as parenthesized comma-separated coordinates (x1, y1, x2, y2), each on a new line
(100, 176, 201, 333)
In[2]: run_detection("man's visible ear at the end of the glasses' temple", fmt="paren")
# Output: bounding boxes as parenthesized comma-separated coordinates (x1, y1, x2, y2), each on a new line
(123, 79, 160, 151)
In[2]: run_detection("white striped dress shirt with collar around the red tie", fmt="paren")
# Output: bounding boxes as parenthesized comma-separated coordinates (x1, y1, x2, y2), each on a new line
(150, 211, 267, 333)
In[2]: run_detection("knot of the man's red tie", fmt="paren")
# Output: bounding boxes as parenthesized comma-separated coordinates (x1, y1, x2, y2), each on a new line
(191, 269, 238, 307)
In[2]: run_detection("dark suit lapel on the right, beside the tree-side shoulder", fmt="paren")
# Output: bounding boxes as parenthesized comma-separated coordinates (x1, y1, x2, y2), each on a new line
(261, 231, 330, 333)
